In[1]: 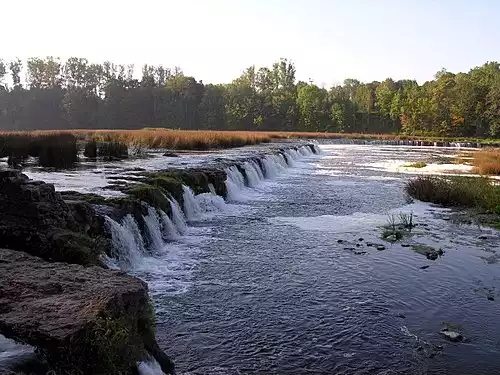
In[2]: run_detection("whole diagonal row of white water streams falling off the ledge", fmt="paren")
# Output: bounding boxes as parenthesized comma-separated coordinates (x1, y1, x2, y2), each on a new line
(106, 146, 313, 270)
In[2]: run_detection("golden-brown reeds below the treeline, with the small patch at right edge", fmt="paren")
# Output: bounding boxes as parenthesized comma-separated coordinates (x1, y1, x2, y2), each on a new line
(0, 128, 500, 170)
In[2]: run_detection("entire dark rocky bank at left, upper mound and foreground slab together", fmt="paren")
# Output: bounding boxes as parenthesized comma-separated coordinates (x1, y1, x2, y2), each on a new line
(0, 169, 173, 373)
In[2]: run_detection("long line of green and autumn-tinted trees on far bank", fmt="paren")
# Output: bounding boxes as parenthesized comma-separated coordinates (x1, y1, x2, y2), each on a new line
(0, 57, 500, 137)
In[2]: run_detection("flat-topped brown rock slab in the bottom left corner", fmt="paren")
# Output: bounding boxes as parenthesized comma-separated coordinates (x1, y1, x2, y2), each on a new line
(0, 249, 174, 374)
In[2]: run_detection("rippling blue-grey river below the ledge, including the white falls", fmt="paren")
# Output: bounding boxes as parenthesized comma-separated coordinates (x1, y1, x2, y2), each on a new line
(0, 144, 500, 375)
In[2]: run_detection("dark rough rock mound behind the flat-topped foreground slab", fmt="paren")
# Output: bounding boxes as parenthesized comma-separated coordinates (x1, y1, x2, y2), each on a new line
(0, 170, 110, 264)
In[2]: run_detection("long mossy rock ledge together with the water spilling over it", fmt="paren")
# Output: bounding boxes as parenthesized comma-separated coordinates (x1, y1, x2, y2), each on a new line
(102, 143, 320, 271)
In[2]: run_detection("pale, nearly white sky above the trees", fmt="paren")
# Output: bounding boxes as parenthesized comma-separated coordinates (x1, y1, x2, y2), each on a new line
(0, 0, 500, 86)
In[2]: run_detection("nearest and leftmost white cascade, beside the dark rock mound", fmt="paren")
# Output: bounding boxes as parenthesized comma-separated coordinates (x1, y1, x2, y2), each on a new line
(105, 215, 144, 269)
